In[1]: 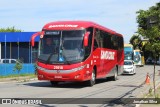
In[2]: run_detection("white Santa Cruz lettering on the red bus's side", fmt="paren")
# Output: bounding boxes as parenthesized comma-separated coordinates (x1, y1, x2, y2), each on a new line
(101, 51, 115, 60)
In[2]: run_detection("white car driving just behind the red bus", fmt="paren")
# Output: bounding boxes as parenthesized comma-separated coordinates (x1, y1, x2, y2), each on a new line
(123, 60, 136, 74)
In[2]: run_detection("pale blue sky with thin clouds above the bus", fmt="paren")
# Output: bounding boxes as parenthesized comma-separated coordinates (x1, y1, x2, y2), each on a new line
(0, 0, 159, 43)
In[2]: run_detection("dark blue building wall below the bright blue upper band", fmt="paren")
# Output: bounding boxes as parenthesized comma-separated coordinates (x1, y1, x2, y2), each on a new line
(1, 42, 38, 63)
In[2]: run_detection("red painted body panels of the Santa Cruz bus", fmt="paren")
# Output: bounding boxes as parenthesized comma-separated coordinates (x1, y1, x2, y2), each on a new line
(34, 21, 124, 81)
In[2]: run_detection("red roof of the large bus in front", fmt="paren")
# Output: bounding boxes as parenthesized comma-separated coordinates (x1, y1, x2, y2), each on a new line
(42, 21, 122, 36)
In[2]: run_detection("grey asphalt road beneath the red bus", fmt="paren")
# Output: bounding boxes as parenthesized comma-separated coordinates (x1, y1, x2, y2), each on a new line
(0, 65, 160, 107)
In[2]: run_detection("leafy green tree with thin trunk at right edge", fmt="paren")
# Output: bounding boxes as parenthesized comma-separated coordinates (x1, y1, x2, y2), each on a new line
(137, 3, 160, 97)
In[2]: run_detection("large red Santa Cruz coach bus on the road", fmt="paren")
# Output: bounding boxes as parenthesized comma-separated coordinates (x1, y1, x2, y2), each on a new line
(31, 21, 124, 86)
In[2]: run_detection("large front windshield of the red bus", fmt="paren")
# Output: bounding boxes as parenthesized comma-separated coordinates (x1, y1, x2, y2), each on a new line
(38, 30, 85, 64)
